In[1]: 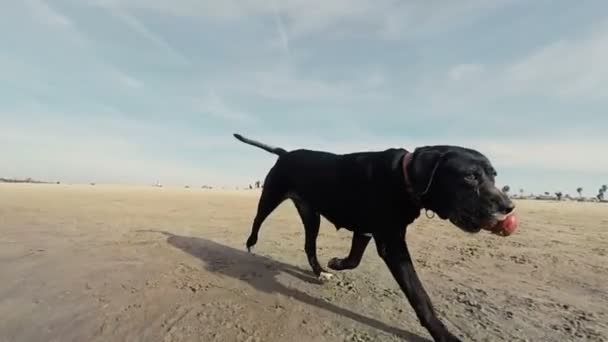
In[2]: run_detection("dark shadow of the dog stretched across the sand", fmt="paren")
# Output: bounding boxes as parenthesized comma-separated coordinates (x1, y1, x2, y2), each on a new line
(141, 230, 429, 342)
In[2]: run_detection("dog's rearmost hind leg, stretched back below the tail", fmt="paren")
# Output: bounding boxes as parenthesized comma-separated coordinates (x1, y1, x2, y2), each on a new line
(247, 169, 287, 252)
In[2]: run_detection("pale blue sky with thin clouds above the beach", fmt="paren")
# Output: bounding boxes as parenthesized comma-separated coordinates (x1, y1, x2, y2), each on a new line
(0, 0, 608, 195)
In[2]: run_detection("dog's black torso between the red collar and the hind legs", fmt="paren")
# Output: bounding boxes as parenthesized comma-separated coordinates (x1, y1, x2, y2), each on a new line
(273, 149, 414, 230)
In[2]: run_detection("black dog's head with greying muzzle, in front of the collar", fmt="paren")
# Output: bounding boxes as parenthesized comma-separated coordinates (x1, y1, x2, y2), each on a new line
(408, 146, 515, 233)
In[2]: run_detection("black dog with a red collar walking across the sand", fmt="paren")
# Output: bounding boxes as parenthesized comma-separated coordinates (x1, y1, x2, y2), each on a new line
(234, 134, 514, 341)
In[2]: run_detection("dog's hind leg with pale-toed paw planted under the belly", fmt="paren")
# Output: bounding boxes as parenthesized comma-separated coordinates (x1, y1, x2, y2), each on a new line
(292, 198, 332, 280)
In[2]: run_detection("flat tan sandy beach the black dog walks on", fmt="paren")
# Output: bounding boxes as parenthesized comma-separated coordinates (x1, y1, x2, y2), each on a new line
(0, 184, 608, 341)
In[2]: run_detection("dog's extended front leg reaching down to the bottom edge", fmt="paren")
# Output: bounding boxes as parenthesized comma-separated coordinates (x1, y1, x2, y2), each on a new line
(374, 236, 460, 342)
